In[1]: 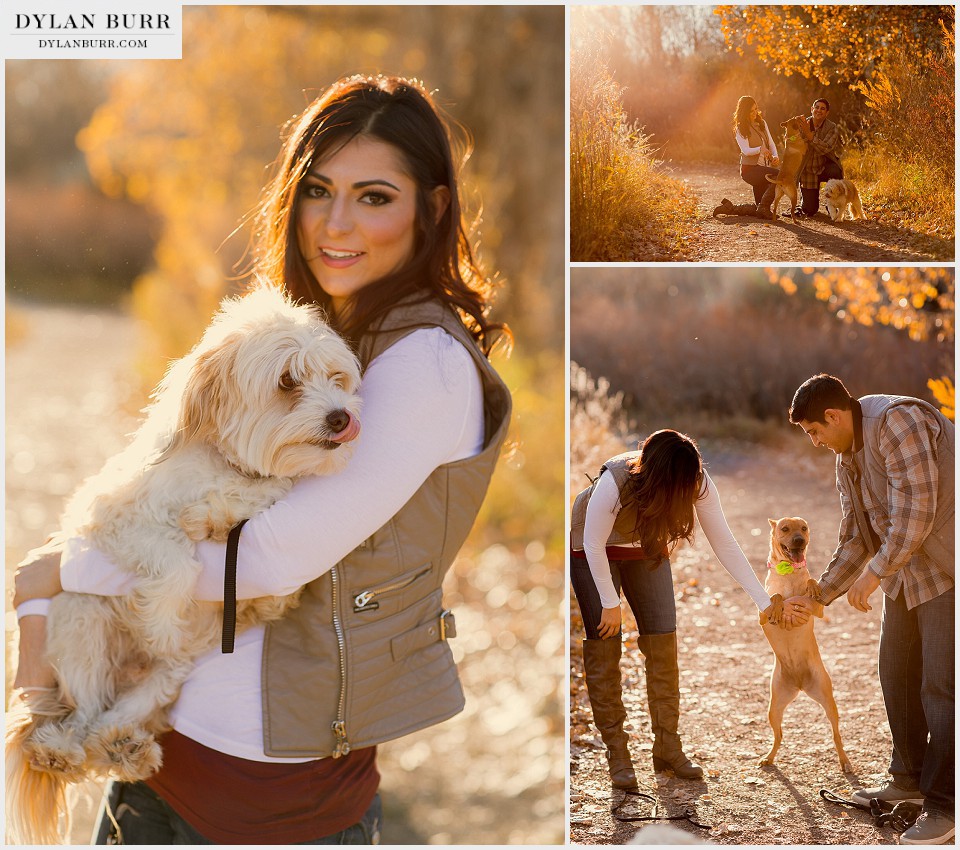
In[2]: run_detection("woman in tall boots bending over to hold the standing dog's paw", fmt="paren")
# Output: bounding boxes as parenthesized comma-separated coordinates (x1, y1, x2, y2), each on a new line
(570, 430, 771, 788)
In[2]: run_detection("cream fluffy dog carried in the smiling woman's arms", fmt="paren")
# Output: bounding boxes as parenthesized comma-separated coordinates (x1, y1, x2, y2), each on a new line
(6, 286, 360, 844)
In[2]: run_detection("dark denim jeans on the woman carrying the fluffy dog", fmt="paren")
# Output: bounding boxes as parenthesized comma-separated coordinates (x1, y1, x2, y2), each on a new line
(93, 782, 383, 844)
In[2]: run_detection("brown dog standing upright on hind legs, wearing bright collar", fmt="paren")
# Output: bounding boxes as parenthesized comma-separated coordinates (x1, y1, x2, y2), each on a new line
(760, 517, 853, 773)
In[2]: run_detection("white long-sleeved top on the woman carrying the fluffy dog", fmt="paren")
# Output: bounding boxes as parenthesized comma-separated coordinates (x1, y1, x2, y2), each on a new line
(60, 328, 484, 762)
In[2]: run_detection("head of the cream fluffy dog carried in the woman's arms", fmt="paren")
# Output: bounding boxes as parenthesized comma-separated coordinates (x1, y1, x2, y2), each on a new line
(163, 289, 360, 477)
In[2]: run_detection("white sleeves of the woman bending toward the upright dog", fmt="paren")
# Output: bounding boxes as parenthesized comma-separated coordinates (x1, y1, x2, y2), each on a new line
(583, 472, 770, 611)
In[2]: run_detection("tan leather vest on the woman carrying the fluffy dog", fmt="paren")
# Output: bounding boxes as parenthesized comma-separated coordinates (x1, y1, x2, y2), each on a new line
(255, 301, 511, 758)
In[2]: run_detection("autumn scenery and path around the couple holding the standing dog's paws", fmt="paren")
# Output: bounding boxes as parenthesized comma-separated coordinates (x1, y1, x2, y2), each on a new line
(569, 266, 955, 846)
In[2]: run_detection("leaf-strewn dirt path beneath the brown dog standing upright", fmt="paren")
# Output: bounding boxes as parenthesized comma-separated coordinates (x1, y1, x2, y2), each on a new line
(570, 446, 896, 845)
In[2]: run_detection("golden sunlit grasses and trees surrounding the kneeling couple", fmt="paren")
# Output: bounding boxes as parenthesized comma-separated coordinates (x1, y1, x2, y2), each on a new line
(570, 4, 955, 261)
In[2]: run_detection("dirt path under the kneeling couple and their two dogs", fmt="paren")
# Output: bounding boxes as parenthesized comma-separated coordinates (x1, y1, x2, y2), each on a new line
(666, 163, 954, 263)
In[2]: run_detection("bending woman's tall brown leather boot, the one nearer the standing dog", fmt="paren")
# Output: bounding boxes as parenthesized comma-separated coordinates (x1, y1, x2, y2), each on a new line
(637, 632, 703, 779)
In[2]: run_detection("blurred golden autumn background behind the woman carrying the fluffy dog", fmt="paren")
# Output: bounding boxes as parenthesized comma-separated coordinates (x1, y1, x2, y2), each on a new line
(6, 6, 566, 844)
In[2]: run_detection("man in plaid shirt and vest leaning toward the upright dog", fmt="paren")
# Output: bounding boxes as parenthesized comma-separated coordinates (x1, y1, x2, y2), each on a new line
(784, 375, 955, 844)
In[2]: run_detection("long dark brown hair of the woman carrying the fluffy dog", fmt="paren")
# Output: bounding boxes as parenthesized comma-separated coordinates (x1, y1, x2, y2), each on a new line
(254, 75, 509, 354)
